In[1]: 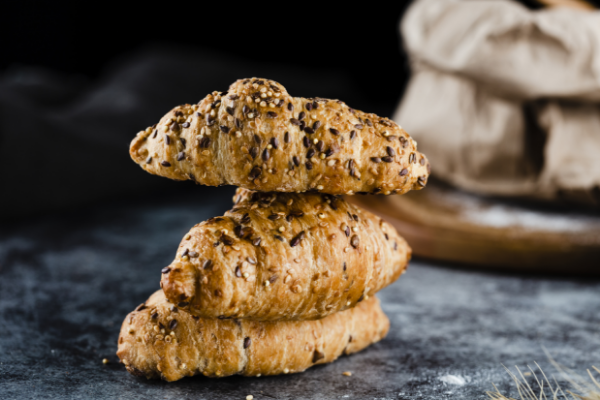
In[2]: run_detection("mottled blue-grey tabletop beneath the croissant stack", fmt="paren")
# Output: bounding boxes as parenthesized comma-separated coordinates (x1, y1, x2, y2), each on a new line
(0, 188, 600, 399)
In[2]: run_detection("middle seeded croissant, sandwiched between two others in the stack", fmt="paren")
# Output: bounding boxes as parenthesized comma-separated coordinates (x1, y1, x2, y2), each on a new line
(161, 189, 411, 321)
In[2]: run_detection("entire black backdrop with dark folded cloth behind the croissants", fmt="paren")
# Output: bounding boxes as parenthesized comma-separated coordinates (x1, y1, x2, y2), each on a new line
(0, 0, 598, 219)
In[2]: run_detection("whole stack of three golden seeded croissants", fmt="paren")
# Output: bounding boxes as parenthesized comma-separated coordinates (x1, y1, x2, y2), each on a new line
(117, 78, 430, 381)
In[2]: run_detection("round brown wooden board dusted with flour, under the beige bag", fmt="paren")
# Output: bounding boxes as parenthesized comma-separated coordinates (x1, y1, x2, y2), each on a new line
(347, 182, 600, 275)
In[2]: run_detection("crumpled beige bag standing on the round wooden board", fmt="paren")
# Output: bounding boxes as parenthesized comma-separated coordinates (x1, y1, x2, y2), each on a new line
(394, 0, 600, 205)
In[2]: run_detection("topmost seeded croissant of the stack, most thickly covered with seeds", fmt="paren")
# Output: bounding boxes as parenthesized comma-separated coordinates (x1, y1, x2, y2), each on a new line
(130, 79, 430, 194)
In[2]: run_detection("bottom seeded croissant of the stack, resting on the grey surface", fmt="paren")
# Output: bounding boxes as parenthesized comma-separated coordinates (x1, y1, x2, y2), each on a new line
(117, 291, 389, 382)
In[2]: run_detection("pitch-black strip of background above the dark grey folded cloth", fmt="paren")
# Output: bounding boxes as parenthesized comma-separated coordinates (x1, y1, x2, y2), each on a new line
(0, 0, 564, 111)
